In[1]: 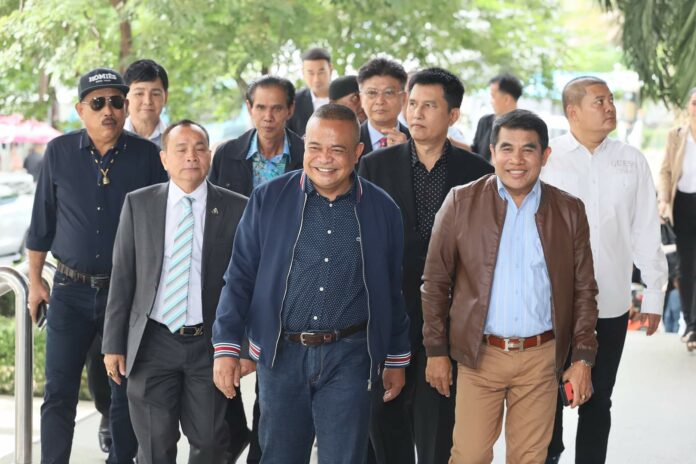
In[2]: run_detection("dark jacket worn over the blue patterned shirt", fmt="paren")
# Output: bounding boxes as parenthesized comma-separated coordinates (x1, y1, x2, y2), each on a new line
(208, 129, 304, 197)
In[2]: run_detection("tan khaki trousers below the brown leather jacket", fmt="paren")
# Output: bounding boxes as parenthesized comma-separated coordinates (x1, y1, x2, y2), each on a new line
(450, 340, 558, 464)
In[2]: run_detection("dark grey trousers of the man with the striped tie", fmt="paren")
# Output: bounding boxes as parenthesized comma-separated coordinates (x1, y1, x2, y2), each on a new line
(128, 321, 229, 464)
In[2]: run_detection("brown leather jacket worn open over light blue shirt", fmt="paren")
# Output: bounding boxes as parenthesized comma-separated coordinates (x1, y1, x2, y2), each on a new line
(421, 175, 598, 374)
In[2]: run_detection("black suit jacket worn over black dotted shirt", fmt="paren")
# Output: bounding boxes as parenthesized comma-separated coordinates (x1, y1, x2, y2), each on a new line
(358, 143, 493, 350)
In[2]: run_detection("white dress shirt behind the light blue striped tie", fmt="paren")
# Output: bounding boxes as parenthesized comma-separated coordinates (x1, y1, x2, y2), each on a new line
(150, 181, 208, 325)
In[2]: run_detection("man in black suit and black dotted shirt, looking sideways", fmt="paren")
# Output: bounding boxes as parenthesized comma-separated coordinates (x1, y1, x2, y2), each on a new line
(359, 68, 493, 464)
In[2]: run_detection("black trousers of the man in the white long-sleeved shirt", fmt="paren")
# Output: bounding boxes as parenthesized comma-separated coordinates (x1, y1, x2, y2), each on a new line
(548, 312, 628, 464)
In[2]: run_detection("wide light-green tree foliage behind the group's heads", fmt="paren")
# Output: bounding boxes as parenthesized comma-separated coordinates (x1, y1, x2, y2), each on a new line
(0, 0, 563, 125)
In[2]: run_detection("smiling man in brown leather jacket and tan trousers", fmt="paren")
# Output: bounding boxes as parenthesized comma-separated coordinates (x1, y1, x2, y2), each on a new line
(422, 110, 597, 464)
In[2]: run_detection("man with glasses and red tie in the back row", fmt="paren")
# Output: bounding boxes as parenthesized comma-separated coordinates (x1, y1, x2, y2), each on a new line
(358, 58, 411, 157)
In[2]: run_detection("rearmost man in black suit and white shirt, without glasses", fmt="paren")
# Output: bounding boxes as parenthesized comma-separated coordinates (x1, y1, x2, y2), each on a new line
(288, 48, 333, 137)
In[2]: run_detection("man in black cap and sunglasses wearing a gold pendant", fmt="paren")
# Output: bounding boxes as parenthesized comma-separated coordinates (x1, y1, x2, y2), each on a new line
(27, 68, 167, 463)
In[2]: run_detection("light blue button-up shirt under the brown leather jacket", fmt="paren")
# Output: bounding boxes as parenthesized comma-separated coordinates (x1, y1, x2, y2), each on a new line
(484, 179, 553, 338)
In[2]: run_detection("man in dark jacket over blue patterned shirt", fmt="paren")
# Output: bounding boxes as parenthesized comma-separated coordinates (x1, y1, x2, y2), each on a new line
(208, 76, 304, 196)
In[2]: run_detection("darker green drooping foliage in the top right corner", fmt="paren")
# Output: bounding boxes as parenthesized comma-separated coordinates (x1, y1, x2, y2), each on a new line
(600, 0, 696, 105)
